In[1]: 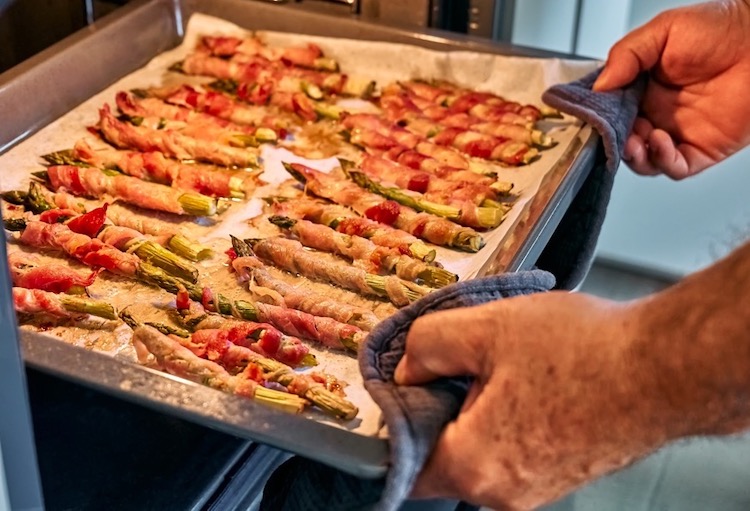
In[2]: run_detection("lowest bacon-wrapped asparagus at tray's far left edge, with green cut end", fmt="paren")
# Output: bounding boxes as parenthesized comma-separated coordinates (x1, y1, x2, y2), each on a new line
(13, 287, 117, 319)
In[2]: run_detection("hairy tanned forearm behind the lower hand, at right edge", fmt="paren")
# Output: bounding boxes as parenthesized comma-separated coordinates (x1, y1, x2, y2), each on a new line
(633, 243, 750, 440)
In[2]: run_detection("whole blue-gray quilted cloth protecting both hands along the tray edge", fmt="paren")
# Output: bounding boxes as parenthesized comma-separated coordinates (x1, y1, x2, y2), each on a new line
(261, 72, 645, 511)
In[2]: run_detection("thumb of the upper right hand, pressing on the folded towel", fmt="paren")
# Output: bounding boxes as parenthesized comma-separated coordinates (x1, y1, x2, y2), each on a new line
(593, 16, 671, 92)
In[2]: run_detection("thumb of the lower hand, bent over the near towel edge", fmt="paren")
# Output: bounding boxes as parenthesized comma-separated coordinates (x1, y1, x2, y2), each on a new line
(394, 307, 493, 385)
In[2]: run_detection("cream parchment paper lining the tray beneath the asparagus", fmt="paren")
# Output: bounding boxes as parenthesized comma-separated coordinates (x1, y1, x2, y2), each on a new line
(0, 14, 596, 435)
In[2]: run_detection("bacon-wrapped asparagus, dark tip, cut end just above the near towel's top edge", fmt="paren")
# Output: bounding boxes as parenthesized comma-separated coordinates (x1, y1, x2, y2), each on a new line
(268, 216, 458, 288)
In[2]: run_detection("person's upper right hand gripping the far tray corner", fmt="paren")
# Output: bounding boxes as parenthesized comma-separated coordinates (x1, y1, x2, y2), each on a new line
(594, 0, 750, 179)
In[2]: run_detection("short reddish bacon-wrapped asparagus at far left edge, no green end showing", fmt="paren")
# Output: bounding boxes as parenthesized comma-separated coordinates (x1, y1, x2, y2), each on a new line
(8, 252, 99, 294)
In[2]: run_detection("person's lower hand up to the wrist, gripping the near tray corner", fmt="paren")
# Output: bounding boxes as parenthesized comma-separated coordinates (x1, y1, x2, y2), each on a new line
(395, 292, 665, 510)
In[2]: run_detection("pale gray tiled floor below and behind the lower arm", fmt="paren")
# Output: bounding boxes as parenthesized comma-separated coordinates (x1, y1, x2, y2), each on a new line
(544, 264, 750, 511)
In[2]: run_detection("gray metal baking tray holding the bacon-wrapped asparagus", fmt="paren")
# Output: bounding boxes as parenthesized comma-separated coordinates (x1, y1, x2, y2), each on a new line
(0, 0, 598, 477)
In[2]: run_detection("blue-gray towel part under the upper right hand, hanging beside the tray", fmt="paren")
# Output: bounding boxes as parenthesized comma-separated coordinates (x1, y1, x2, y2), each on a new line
(536, 70, 646, 289)
